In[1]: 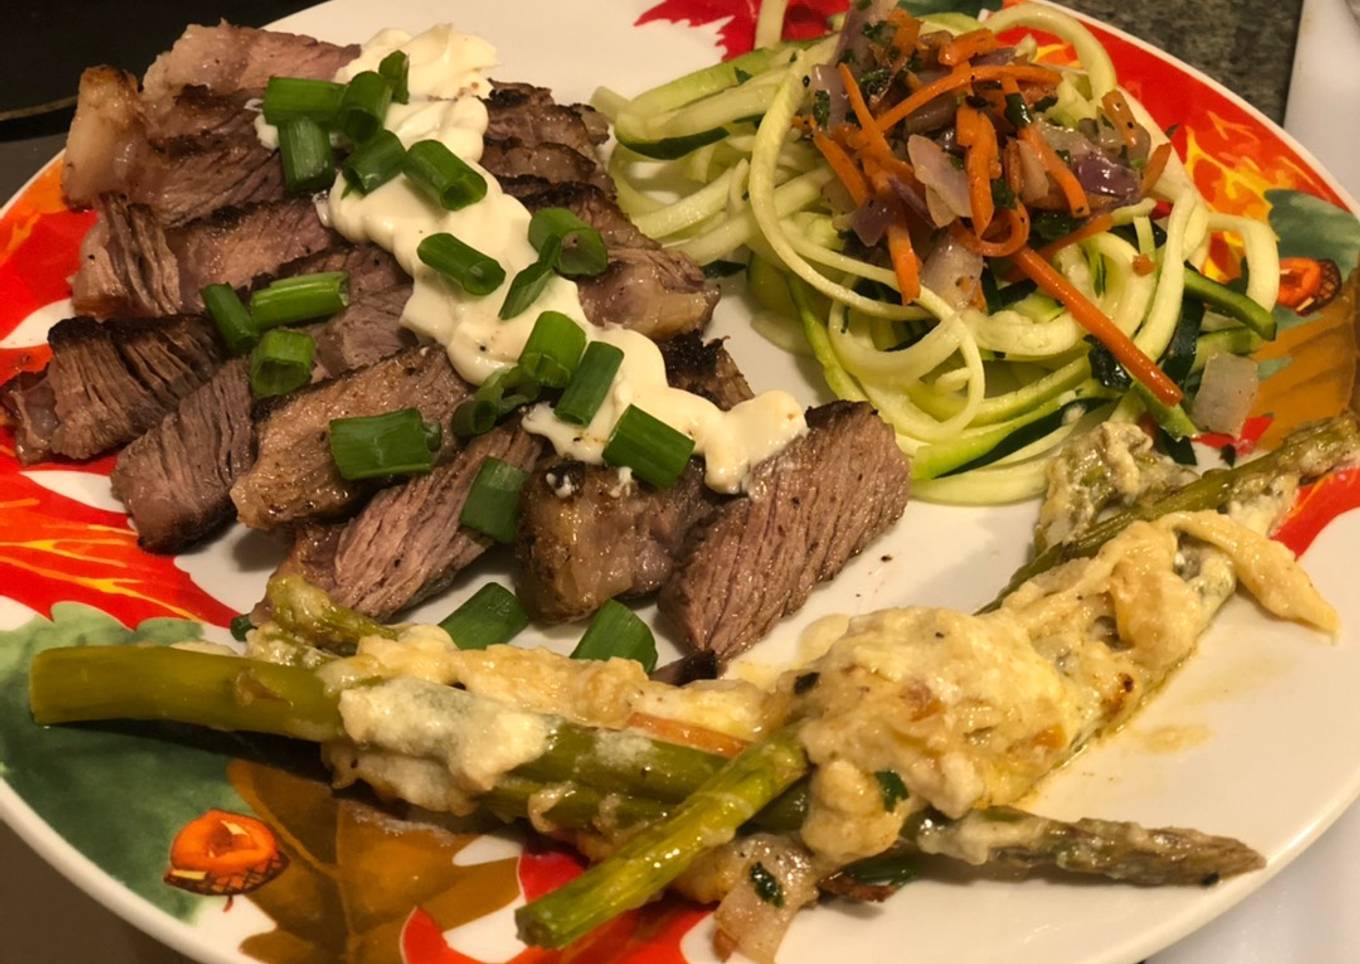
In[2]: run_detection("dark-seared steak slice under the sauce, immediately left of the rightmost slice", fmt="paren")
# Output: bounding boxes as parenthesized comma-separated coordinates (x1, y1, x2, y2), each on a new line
(515, 334, 751, 623)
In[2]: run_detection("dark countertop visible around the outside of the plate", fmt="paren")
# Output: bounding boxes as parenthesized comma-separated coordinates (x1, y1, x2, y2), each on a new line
(0, 0, 1316, 964)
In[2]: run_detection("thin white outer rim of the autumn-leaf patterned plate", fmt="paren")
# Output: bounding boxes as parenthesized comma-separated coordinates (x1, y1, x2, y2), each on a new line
(0, 0, 1360, 964)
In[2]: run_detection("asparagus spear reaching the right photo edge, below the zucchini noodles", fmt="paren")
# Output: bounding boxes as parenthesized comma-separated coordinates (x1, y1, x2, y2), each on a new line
(981, 413, 1360, 612)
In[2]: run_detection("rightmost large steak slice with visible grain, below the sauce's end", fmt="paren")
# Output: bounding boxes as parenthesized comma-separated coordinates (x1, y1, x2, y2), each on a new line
(658, 401, 908, 659)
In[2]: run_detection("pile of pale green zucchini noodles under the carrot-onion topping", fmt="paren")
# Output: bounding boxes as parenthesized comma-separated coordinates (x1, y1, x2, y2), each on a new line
(606, 0, 1280, 504)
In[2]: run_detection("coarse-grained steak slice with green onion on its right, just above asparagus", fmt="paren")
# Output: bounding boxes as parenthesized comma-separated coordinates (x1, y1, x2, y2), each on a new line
(284, 424, 543, 619)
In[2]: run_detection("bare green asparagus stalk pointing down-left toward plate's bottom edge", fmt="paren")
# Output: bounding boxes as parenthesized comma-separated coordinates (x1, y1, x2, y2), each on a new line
(515, 727, 808, 948)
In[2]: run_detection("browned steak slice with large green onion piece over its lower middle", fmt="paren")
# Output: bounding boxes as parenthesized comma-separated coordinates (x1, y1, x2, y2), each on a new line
(231, 348, 471, 529)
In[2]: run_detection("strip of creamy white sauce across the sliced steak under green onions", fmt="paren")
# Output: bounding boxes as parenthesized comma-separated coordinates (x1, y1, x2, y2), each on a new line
(257, 24, 806, 492)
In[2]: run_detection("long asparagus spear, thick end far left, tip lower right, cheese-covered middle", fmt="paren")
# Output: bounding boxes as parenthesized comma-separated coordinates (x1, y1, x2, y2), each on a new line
(29, 646, 1261, 889)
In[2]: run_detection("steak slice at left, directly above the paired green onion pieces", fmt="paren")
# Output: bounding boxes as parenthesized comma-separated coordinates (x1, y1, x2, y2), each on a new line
(71, 196, 340, 317)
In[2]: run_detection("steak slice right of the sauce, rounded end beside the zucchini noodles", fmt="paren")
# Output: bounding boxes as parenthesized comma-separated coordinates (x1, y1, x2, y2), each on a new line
(507, 179, 719, 341)
